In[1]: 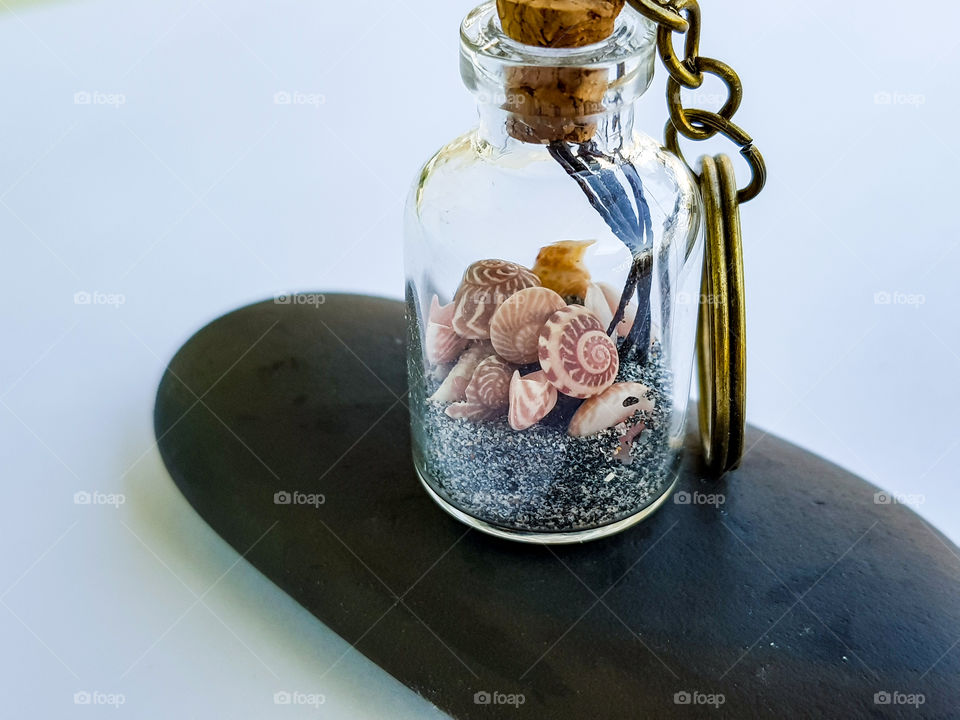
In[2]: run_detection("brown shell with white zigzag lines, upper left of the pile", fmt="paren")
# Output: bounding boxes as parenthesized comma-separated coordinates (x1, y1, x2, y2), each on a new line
(451, 260, 540, 340)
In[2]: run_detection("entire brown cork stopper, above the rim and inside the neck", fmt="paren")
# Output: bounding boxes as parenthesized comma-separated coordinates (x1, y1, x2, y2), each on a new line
(497, 0, 624, 143)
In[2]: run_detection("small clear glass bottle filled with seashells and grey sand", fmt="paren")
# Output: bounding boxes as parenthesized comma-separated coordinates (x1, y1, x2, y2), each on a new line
(405, 2, 703, 543)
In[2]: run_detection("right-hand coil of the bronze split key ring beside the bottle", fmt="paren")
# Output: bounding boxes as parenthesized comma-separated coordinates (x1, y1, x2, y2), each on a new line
(714, 155, 747, 472)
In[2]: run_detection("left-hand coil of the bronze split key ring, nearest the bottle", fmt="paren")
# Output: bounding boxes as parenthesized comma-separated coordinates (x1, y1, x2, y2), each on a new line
(697, 156, 730, 476)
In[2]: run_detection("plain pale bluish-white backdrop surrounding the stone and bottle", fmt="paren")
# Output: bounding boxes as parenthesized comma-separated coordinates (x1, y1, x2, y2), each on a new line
(0, 0, 960, 718)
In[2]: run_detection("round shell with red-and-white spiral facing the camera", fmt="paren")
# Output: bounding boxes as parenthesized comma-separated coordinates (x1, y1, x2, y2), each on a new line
(538, 305, 620, 398)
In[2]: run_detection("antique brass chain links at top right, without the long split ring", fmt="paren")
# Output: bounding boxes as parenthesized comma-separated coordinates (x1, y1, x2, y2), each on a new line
(627, 0, 767, 204)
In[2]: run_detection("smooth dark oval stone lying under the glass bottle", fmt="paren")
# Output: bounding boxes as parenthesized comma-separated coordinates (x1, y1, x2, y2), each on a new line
(156, 295, 960, 720)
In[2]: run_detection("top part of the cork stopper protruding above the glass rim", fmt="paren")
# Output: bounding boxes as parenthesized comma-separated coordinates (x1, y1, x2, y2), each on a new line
(497, 0, 624, 48)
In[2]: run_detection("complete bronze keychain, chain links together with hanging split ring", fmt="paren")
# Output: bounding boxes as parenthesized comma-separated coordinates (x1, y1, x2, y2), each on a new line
(627, 0, 767, 477)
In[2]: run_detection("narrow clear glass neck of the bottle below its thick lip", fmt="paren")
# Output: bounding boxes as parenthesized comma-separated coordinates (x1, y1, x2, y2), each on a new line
(477, 101, 637, 155)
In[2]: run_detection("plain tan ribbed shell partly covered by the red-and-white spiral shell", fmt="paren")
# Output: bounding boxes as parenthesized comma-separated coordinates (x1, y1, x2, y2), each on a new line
(490, 287, 567, 365)
